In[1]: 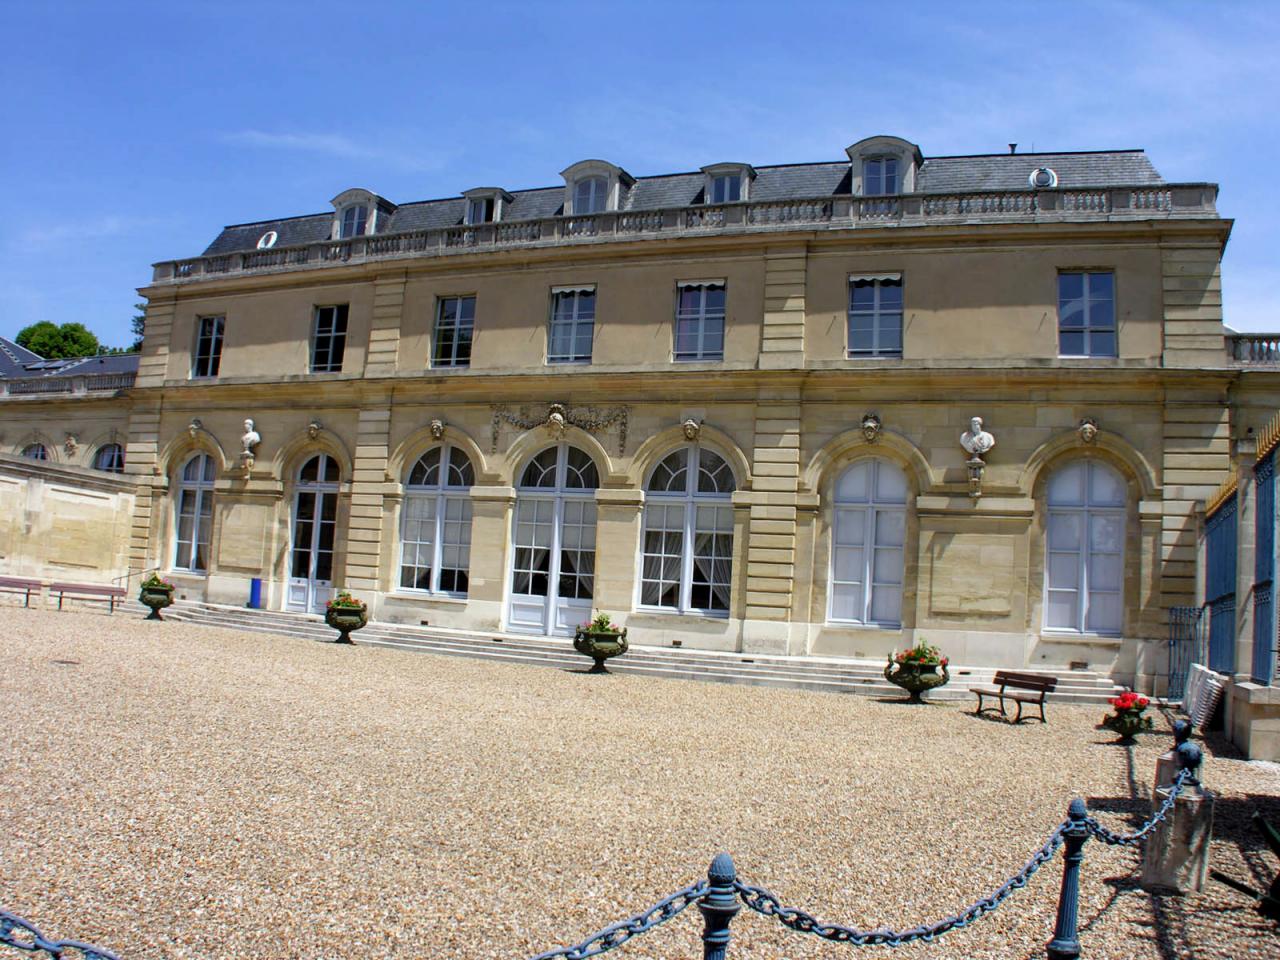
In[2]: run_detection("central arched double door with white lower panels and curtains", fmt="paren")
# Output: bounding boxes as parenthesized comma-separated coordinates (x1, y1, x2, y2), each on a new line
(507, 443, 600, 636)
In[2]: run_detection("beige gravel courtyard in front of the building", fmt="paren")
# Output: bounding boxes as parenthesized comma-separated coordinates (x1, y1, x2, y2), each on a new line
(0, 608, 1280, 960)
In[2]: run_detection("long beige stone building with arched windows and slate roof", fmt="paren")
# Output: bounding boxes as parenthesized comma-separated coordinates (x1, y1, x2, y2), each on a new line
(0, 137, 1280, 752)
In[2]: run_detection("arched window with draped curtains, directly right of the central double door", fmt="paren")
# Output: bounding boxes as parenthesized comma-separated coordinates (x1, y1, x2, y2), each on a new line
(640, 445, 735, 617)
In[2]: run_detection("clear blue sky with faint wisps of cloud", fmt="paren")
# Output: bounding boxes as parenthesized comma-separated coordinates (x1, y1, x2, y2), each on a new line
(0, 0, 1280, 344)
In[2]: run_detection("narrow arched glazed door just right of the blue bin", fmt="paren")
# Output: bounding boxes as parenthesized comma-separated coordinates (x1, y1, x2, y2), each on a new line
(287, 453, 340, 613)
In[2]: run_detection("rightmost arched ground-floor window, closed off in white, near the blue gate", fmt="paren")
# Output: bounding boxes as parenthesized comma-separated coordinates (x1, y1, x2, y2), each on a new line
(1044, 460, 1128, 635)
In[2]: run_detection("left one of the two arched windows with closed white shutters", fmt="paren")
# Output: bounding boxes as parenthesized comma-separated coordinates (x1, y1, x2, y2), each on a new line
(827, 458, 906, 627)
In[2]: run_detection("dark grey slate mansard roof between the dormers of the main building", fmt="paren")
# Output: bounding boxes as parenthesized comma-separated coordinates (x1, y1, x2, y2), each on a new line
(205, 150, 1165, 256)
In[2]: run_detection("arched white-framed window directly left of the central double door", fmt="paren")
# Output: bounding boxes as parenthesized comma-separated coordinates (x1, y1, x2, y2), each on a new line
(401, 445, 475, 596)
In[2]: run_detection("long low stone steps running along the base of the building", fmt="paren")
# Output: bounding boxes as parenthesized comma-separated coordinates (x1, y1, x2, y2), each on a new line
(164, 600, 1123, 704)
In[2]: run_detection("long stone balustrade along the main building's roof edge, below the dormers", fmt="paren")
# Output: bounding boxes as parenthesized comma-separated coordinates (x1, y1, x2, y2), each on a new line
(154, 183, 1217, 283)
